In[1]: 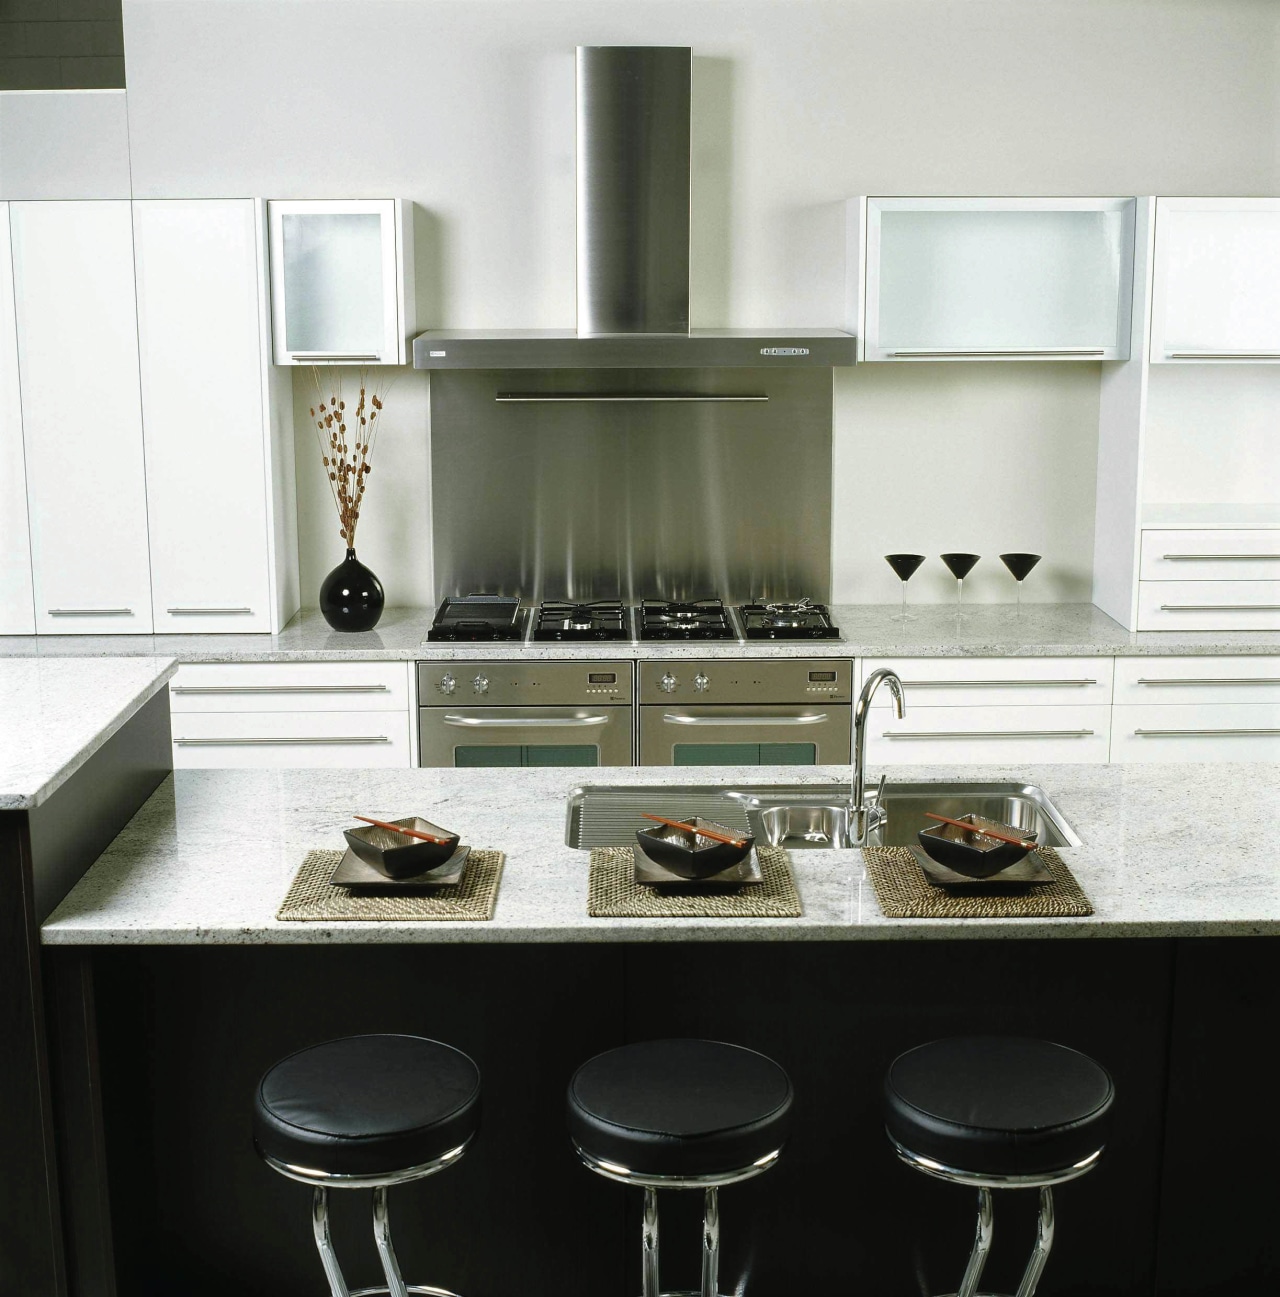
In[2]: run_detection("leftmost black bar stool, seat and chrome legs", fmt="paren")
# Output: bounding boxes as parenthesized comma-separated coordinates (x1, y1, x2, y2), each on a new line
(253, 1035, 480, 1297)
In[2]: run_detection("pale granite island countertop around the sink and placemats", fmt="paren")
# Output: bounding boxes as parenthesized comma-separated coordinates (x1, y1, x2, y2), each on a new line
(43, 764, 1280, 946)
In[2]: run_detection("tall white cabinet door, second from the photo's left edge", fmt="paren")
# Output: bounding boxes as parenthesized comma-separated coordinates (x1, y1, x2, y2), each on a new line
(9, 200, 152, 634)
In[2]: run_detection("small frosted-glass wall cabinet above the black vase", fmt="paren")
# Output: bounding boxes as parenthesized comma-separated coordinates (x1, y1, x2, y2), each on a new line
(267, 198, 416, 364)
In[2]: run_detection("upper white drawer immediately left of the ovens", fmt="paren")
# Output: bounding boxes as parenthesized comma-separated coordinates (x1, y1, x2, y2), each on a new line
(169, 661, 410, 724)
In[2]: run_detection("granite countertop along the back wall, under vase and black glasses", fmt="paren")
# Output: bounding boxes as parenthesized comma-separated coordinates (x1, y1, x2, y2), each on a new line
(0, 603, 1280, 663)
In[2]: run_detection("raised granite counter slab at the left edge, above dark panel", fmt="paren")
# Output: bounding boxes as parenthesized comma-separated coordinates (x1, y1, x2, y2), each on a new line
(0, 658, 178, 811)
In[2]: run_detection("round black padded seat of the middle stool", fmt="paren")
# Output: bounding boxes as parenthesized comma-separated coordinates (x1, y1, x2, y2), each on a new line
(568, 1040, 791, 1176)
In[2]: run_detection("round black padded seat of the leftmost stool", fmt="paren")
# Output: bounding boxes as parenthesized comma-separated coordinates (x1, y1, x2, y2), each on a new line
(253, 1035, 480, 1175)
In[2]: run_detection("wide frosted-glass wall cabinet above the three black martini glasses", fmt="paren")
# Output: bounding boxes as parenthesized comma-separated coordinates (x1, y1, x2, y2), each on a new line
(851, 198, 1136, 361)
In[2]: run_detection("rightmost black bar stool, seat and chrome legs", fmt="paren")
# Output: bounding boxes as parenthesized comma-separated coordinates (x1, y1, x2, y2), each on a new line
(884, 1036, 1115, 1297)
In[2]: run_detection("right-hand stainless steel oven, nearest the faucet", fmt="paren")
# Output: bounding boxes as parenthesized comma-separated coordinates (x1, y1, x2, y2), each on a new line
(639, 658, 853, 765)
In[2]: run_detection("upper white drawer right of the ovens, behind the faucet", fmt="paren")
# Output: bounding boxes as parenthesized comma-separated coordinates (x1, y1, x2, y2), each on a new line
(861, 658, 1113, 716)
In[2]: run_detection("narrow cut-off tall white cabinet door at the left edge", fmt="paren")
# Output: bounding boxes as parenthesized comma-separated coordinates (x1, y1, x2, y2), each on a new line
(0, 202, 35, 636)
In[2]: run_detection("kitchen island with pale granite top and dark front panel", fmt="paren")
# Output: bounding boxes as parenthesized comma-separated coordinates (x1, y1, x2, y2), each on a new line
(41, 765, 1280, 1297)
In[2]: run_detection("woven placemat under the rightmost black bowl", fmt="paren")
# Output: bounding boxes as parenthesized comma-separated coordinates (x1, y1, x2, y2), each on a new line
(862, 847, 1093, 918)
